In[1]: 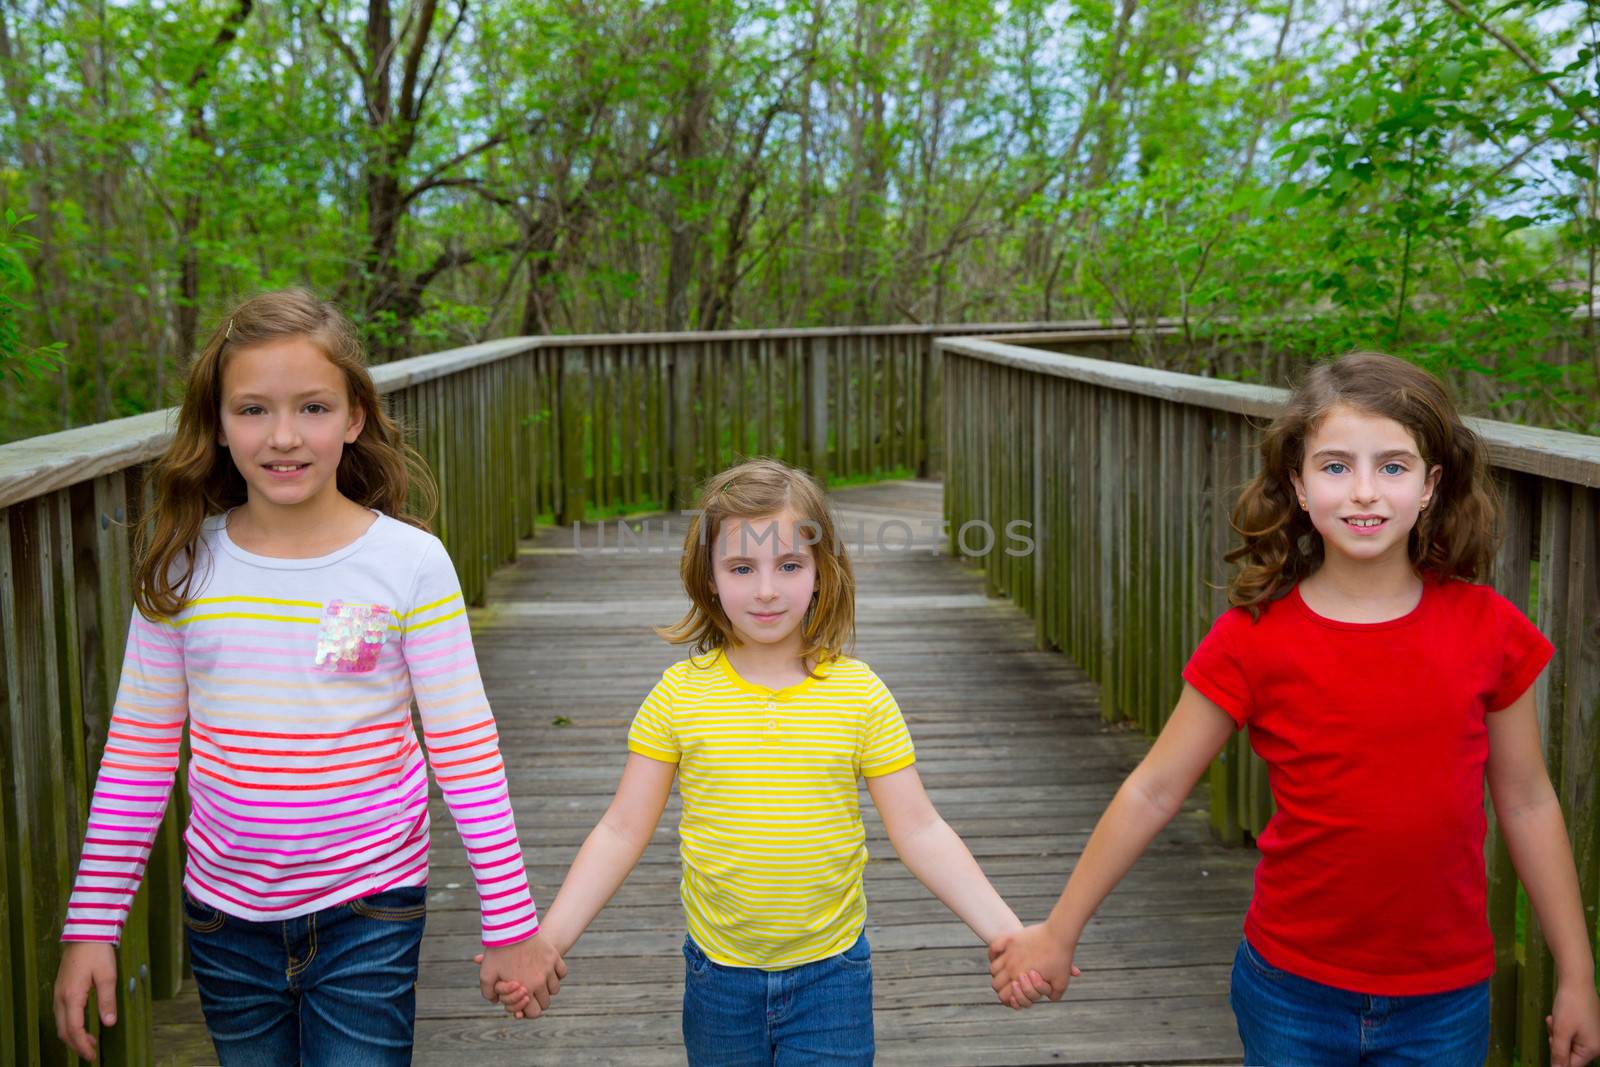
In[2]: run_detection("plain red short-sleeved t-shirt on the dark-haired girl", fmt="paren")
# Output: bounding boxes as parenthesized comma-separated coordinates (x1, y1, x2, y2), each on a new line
(1184, 581, 1552, 997)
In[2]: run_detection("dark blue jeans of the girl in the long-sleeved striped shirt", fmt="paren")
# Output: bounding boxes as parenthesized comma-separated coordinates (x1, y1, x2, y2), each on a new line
(184, 886, 427, 1067)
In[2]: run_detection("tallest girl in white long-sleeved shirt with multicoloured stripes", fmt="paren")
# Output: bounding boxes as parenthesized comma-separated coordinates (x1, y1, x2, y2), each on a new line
(56, 290, 565, 1064)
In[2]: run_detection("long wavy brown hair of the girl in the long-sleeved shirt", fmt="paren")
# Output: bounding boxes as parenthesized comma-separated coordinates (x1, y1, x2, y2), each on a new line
(133, 288, 438, 619)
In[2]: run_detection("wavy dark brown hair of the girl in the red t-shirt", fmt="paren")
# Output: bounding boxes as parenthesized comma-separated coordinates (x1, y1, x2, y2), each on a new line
(1226, 352, 1499, 617)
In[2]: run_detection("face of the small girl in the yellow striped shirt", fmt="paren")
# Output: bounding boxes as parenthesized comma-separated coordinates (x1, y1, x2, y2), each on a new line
(712, 509, 816, 651)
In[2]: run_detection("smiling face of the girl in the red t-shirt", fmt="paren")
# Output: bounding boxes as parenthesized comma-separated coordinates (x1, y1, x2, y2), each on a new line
(1290, 405, 1442, 563)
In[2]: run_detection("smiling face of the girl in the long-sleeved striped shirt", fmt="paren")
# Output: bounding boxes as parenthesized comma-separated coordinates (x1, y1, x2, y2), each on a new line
(218, 338, 365, 507)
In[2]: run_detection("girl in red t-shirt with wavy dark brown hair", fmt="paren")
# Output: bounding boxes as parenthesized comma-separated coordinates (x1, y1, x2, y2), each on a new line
(990, 352, 1600, 1067)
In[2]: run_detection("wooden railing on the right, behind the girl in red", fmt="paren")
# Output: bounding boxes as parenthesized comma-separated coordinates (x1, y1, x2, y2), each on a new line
(936, 336, 1600, 1067)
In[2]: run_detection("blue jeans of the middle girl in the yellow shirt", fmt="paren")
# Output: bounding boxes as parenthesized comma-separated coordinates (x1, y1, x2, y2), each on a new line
(683, 934, 874, 1067)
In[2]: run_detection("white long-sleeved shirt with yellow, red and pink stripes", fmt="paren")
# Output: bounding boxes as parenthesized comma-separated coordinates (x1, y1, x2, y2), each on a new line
(62, 515, 539, 945)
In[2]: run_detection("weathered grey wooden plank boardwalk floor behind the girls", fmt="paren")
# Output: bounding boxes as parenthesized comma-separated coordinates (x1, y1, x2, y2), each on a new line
(157, 482, 1254, 1067)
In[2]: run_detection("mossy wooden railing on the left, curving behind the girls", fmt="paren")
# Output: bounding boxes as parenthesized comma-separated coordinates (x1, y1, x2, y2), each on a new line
(0, 323, 1126, 1064)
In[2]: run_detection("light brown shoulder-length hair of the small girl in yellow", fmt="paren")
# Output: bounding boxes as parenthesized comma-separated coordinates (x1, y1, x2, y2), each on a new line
(656, 459, 856, 670)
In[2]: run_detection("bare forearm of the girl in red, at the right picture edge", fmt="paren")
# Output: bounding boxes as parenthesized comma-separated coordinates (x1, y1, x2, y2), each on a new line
(1496, 792, 1594, 982)
